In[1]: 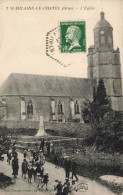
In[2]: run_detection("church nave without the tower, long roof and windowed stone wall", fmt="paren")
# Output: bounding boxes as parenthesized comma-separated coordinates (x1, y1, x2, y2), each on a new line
(0, 74, 96, 121)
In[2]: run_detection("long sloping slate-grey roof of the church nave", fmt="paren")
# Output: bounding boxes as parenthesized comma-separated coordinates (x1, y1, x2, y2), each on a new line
(0, 73, 96, 98)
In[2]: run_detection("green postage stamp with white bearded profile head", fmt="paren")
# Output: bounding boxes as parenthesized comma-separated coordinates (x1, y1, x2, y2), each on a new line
(60, 21, 86, 53)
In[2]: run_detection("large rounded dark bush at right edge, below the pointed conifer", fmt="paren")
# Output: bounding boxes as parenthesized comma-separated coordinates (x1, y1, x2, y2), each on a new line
(95, 111, 122, 153)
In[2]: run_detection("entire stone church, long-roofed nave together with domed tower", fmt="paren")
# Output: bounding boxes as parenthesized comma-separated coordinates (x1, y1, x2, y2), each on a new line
(0, 12, 123, 122)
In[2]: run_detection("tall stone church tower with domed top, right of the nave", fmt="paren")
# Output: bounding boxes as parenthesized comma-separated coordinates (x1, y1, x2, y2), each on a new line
(88, 12, 123, 111)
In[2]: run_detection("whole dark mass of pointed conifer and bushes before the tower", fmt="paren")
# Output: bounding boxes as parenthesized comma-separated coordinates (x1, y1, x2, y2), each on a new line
(82, 79, 123, 153)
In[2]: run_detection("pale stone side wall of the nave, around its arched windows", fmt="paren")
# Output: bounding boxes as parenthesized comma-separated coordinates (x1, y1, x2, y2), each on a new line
(2, 96, 88, 122)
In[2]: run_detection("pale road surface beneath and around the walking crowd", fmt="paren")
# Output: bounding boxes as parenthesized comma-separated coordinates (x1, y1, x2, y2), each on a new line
(0, 153, 114, 195)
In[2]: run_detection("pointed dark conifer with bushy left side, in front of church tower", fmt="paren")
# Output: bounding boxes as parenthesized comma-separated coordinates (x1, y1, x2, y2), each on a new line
(82, 79, 111, 123)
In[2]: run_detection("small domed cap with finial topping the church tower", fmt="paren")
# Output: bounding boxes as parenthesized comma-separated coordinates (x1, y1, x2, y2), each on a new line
(95, 12, 111, 28)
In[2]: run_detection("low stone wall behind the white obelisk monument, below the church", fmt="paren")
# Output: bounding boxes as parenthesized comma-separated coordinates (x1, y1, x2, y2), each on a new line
(0, 120, 93, 138)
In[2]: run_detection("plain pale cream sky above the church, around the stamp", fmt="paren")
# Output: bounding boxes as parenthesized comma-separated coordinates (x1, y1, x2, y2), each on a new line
(0, 0, 123, 85)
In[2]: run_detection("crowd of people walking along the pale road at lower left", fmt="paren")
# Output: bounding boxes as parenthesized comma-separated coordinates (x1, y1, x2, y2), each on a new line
(4, 139, 78, 195)
